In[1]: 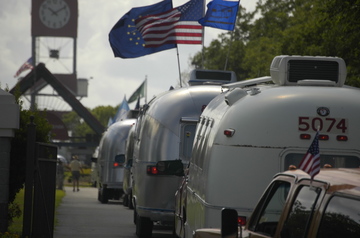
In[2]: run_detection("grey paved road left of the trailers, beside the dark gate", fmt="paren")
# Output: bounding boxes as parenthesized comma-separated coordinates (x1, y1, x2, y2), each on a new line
(54, 187, 171, 238)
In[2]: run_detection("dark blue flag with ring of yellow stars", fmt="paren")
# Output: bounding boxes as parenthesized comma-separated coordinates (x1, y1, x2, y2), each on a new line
(109, 0, 176, 58)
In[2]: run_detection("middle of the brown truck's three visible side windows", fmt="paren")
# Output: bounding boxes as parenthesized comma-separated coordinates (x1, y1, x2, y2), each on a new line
(281, 186, 321, 238)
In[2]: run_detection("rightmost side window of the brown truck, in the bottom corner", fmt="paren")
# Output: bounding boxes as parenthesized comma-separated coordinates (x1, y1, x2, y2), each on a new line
(316, 196, 360, 238)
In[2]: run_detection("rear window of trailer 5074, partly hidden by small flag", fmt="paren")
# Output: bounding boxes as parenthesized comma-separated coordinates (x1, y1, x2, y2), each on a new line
(284, 153, 360, 170)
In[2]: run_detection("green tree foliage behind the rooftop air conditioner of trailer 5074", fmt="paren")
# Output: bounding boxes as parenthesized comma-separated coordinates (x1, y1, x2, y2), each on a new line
(191, 0, 360, 87)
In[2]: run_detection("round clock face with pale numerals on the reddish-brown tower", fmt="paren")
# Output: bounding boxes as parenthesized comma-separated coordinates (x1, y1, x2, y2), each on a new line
(39, 0, 70, 29)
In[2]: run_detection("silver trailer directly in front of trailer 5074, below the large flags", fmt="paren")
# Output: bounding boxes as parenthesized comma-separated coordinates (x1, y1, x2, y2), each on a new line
(132, 70, 236, 237)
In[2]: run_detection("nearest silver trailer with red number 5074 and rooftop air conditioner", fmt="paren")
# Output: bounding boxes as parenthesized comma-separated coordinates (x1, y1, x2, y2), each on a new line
(165, 55, 360, 238)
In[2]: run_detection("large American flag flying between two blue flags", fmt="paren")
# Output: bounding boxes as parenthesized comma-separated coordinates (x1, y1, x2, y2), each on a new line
(135, 0, 204, 47)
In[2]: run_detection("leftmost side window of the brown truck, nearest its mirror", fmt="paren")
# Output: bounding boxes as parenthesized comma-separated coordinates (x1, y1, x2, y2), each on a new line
(249, 181, 290, 236)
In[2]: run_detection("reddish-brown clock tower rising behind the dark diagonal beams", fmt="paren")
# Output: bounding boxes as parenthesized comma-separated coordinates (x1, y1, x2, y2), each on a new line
(31, 0, 78, 96)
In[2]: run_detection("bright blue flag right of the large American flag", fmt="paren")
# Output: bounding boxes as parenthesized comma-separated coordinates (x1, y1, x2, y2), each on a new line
(199, 0, 240, 31)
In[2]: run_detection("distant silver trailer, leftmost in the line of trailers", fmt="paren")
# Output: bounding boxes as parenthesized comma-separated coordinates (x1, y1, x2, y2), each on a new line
(97, 119, 136, 203)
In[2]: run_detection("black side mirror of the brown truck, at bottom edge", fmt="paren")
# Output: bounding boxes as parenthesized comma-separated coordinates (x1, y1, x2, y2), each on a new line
(221, 208, 238, 238)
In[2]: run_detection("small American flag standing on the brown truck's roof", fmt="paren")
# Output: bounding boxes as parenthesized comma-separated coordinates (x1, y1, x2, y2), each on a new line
(299, 131, 320, 179)
